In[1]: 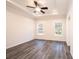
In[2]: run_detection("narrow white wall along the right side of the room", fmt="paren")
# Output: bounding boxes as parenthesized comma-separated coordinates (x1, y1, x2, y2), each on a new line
(66, 4, 73, 56)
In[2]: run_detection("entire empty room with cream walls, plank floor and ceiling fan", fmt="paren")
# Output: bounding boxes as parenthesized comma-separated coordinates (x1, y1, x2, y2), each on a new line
(6, 0, 73, 59)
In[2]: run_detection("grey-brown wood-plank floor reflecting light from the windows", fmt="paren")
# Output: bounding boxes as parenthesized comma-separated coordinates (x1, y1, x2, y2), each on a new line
(6, 40, 72, 59)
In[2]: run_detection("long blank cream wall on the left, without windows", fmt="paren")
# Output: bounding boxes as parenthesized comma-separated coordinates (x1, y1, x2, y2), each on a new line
(6, 8, 35, 48)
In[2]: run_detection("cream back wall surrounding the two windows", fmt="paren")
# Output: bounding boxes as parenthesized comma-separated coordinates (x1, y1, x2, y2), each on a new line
(35, 16, 65, 41)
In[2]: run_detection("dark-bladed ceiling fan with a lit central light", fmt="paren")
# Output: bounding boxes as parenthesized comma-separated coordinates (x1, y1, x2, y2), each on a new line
(26, 1, 48, 14)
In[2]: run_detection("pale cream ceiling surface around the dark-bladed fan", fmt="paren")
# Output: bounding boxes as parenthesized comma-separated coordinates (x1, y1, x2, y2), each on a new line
(7, 0, 71, 16)
